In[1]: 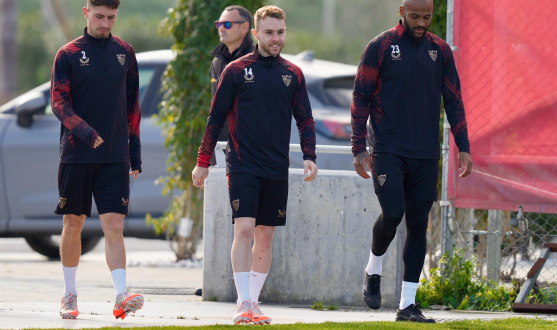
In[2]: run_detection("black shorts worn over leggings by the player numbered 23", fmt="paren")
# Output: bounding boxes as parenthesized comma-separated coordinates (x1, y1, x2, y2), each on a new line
(371, 152, 439, 202)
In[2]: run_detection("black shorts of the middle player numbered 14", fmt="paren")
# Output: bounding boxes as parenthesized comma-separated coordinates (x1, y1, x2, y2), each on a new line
(228, 173, 288, 226)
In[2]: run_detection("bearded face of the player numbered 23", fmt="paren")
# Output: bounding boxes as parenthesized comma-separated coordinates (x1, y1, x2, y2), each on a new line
(400, 0, 433, 40)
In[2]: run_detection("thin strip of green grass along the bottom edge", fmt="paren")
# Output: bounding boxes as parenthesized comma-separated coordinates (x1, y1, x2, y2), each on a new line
(13, 318, 557, 330)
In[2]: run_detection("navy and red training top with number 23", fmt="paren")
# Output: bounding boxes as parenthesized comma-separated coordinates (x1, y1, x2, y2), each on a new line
(350, 22, 470, 159)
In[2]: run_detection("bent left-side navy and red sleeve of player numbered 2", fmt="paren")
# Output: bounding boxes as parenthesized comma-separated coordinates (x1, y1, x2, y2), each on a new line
(50, 49, 99, 148)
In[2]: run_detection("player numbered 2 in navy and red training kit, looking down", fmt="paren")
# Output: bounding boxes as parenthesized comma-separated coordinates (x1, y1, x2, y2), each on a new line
(51, 0, 143, 319)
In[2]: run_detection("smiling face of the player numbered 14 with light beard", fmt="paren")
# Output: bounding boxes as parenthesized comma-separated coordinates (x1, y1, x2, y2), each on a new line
(252, 17, 286, 56)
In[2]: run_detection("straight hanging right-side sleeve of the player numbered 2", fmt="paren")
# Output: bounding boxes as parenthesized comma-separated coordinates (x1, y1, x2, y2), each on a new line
(126, 48, 141, 173)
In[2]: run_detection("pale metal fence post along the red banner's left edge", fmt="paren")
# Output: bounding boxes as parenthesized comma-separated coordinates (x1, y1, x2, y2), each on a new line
(441, 0, 454, 255)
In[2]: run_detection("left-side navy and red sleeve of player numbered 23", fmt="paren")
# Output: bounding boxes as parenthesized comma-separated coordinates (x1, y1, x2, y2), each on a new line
(350, 42, 379, 157)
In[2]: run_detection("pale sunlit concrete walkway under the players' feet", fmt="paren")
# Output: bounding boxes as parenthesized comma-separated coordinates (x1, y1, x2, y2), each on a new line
(0, 239, 557, 329)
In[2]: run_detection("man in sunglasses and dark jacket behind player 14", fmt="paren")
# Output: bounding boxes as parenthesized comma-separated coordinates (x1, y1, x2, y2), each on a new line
(210, 6, 255, 146)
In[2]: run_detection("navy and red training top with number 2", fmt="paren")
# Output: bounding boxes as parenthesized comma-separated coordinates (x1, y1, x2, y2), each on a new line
(50, 28, 141, 171)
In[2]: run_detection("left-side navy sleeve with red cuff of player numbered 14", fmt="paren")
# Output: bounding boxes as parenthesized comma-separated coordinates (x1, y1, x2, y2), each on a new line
(197, 66, 236, 168)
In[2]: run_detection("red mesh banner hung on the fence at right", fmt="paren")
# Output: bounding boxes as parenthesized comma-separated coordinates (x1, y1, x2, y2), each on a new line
(448, 0, 557, 213)
